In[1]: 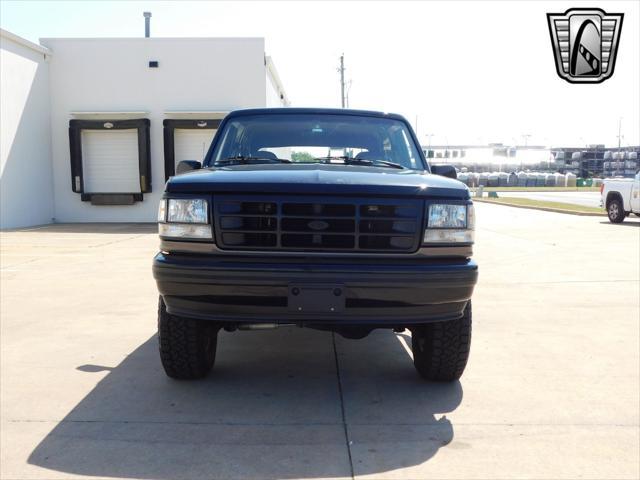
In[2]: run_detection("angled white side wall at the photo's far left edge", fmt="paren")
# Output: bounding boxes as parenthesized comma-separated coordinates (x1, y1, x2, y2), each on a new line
(0, 31, 53, 228)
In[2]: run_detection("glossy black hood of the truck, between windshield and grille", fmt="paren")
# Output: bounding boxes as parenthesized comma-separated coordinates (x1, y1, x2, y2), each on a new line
(166, 164, 469, 200)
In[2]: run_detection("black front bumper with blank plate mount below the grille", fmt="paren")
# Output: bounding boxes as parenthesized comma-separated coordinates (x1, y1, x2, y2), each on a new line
(153, 253, 478, 327)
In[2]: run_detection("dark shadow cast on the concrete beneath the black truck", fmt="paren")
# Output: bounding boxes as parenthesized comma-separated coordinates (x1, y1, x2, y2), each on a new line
(28, 328, 462, 479)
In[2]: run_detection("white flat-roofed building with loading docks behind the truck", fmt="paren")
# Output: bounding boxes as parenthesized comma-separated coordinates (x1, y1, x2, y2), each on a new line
(0, 30, 289, 228)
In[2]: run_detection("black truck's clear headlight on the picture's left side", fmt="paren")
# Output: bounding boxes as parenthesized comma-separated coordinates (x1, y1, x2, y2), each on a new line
(158, 198, 213, 240)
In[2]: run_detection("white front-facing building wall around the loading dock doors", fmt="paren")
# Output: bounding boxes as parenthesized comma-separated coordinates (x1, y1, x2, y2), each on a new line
(41, 38, 267, 222)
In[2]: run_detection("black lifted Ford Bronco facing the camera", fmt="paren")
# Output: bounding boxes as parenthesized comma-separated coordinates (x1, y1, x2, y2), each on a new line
(153, 108, 478, 381)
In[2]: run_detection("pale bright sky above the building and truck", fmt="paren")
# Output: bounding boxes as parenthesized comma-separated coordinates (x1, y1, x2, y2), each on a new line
(0, 0, 640, 146)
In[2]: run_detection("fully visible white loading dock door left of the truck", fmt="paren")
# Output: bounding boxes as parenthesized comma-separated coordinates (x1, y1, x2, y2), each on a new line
(81, 129, 141, 193)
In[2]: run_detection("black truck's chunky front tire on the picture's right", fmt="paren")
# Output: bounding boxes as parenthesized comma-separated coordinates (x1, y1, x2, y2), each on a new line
(411, 301, 471, 382)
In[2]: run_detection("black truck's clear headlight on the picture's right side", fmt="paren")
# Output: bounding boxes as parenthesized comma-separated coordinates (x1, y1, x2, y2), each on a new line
(423, 203, 475, 244)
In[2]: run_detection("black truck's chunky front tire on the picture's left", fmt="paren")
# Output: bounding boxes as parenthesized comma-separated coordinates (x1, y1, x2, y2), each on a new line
(158, 297, 219, 380)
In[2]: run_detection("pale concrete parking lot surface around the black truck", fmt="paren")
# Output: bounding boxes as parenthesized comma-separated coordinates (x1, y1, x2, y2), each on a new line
(0, 204, 640, 479)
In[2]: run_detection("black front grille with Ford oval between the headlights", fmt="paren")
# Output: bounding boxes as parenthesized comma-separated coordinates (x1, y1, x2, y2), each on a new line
(213, 195, 423, 253)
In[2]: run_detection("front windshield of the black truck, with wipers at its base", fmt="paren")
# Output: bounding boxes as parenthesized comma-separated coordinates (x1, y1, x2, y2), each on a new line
(209, 113, 424, 170)
